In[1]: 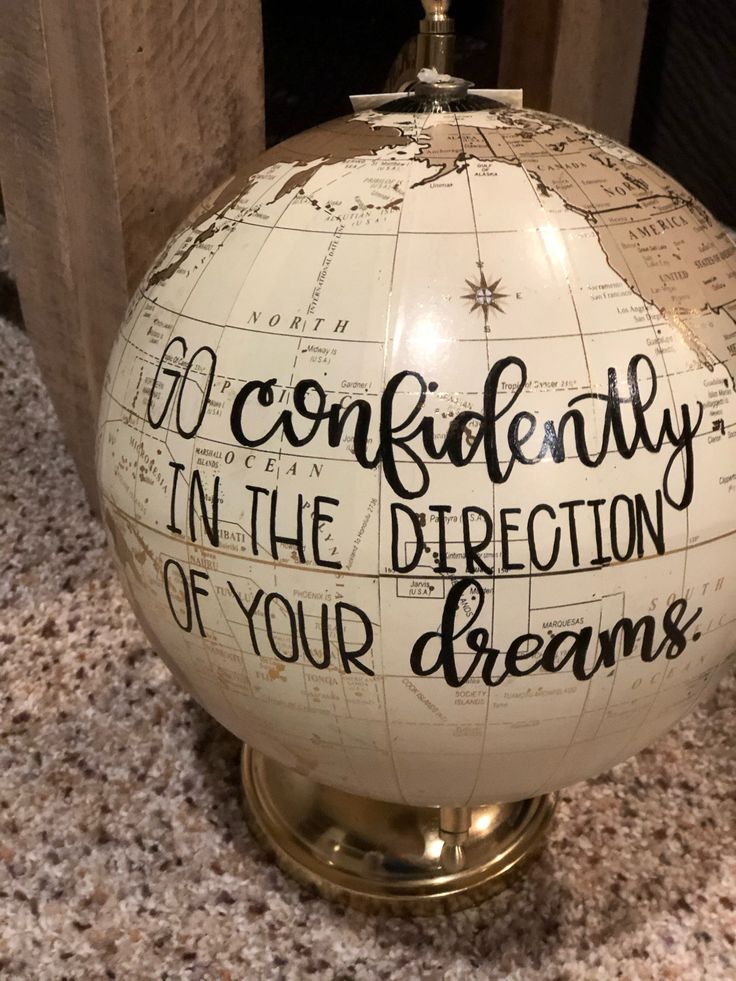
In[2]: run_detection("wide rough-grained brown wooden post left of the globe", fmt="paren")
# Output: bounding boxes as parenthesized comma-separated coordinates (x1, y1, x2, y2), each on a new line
(0, 0, 263, 506)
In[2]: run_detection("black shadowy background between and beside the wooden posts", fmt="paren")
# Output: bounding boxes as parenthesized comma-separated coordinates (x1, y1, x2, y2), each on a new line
(263, 0, 736, 226)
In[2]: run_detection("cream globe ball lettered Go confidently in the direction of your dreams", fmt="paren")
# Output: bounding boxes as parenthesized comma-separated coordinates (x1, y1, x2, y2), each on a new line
(98, 82, 736, 807)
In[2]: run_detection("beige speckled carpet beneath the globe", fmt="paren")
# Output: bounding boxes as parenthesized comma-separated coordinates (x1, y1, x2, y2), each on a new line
(0, 270, 736, 981)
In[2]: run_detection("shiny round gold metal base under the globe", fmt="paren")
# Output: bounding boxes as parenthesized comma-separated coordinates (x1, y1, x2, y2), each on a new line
(242, 746, 556, 915)
